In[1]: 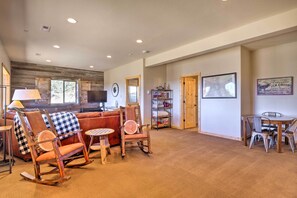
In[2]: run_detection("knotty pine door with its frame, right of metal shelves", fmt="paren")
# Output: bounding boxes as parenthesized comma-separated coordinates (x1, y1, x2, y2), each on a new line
(181, 75, 200, 132)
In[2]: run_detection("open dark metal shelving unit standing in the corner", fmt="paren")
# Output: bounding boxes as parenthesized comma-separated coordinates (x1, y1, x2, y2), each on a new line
(151, 89, 172, 130)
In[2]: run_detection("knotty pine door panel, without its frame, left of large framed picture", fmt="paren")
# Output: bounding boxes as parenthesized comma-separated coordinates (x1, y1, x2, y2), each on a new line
(184, 77, 197, 129)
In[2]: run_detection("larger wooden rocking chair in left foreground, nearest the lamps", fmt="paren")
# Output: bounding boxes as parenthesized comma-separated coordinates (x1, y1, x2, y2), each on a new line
(17, 110, 92, 185)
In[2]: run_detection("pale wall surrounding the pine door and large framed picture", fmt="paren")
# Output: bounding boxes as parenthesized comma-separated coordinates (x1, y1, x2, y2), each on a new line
(167, 47, 241, 139)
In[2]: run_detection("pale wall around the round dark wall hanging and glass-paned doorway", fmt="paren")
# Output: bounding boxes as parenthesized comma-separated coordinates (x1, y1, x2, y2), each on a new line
(104, 60, 144, 109)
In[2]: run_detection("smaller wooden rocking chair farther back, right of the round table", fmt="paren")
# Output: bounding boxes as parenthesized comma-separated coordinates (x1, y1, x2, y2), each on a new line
(120, 105, 152, 157)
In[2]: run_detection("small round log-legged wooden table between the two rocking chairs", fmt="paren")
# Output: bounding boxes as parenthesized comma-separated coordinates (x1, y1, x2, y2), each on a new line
(85, 128, 114, 164)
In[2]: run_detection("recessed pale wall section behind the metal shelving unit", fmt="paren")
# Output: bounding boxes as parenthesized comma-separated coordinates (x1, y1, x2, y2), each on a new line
(143, 65, 166, 124)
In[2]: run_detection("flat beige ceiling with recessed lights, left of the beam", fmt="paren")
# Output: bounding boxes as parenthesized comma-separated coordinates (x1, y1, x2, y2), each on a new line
(0, 0, 297, 71)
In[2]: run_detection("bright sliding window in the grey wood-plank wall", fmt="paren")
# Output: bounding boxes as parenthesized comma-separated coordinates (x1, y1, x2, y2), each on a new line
(51, 80, 77, 104)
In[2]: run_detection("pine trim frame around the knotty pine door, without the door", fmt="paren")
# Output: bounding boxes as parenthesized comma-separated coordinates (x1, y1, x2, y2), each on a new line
(180, 72, 201, 133)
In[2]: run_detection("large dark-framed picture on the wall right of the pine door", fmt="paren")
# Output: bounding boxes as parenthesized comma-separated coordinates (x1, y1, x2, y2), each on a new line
(202, 72, 237, 99)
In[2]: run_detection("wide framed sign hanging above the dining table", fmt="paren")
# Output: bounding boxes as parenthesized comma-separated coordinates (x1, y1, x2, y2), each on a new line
(257, 76, 293, 96)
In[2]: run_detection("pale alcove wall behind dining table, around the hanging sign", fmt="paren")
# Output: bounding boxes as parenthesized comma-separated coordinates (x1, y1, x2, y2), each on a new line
(252, 42, 297, 117)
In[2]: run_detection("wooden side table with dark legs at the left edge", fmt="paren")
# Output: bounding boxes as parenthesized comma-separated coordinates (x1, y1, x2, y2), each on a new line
(0, 126, 14, 173)
